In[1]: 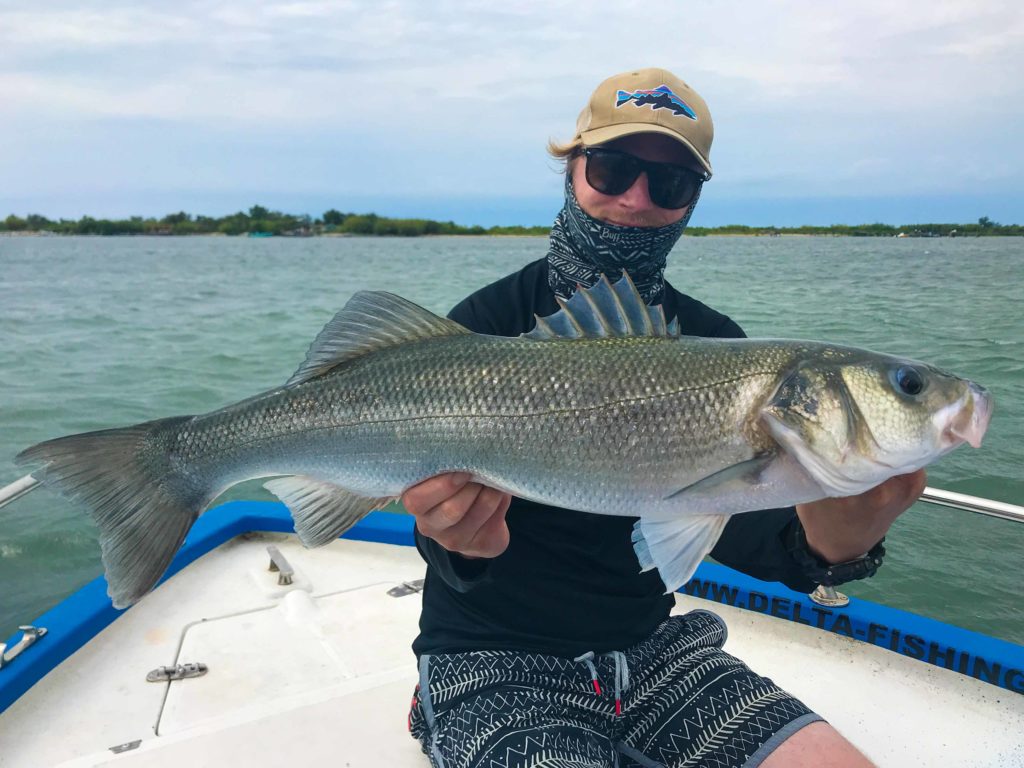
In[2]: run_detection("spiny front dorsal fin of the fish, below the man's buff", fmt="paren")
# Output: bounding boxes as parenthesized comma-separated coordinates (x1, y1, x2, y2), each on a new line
(523, 272, 679, 339)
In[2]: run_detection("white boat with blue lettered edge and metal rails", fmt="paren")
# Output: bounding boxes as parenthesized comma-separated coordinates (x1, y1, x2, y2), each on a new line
(0, 483, 1024, 768)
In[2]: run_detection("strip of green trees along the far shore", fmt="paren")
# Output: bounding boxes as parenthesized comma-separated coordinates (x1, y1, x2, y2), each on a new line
(0, 206, 1024, 238)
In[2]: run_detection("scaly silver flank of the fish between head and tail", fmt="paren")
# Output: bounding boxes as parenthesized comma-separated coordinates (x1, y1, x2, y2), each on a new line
(165, 335, 799, 514)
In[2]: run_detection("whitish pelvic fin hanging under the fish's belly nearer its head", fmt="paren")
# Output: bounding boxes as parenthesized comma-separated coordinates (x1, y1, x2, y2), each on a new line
(633, 515, 730, 593)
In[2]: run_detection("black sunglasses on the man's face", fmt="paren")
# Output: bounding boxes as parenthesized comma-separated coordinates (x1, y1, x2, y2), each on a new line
(583, 146, 708, 209)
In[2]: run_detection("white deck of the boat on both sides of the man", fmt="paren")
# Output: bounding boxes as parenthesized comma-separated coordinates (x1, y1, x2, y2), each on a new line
(0, 534, 1024, 768)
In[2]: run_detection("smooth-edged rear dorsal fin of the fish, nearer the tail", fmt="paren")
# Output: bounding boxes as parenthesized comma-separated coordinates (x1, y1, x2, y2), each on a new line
(285, 291, 470, 387)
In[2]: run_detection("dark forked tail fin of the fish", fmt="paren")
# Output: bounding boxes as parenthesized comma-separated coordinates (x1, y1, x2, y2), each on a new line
(15, 416, 205, 608)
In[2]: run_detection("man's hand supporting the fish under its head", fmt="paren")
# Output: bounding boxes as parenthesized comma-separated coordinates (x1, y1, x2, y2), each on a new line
(797, 469, 927, 563)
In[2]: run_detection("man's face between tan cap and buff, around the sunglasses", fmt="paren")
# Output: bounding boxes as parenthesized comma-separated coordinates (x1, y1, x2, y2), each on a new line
(569, 133, 702, 226)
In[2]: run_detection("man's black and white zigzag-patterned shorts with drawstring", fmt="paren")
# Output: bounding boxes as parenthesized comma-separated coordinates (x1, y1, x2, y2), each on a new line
(409, 610, 821, 768)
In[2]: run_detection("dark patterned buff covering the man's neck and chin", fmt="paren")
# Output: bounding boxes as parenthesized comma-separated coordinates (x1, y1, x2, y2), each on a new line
(548, 171, 700, 304)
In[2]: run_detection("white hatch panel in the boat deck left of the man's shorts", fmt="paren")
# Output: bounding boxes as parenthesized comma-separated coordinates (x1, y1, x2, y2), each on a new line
(158, 582, 421, 736)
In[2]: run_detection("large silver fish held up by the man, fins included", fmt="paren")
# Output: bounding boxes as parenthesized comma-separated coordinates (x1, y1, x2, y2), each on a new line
(17, 278, 990, 607)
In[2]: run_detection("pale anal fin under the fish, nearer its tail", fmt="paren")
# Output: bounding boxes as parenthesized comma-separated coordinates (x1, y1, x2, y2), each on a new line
(263, 475, 391, 547)
